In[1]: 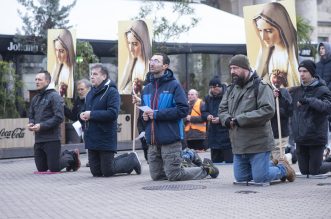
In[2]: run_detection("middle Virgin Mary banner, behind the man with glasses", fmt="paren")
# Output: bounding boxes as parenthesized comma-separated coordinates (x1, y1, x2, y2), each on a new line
(118, 20, 153, 95)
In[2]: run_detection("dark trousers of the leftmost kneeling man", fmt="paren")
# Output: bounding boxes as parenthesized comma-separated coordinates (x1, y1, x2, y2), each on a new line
(34, 141, 74, 172)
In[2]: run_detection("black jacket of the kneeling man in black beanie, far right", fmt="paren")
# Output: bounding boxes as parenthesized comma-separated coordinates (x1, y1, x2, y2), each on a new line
(290, 78, 331, 146)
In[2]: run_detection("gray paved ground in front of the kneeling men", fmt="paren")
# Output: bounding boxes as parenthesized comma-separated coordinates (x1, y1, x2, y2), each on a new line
(0, 150, 331, 219)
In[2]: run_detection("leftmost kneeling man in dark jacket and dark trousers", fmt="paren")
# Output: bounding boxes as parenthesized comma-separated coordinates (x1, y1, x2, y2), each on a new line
(28, 70, 80, 172)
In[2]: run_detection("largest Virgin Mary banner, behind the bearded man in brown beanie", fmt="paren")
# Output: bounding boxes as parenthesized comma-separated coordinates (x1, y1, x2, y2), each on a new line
(244, 0, 300, 87)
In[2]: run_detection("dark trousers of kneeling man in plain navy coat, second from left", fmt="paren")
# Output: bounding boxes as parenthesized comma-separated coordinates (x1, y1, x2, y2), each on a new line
(88, 149, 135, 177)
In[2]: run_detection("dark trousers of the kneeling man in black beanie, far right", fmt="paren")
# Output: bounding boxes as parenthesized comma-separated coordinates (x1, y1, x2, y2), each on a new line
(296, 144, 325, 175)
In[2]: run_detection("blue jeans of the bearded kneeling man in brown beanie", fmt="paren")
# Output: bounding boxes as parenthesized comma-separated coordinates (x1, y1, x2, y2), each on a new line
(233, 152, 286, 183)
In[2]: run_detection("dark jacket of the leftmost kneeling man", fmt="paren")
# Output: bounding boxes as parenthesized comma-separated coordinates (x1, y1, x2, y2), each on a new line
(29, 89, 64, 143)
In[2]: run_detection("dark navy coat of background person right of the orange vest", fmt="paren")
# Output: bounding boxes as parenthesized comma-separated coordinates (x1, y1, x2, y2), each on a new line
(202, 84, 231, 149)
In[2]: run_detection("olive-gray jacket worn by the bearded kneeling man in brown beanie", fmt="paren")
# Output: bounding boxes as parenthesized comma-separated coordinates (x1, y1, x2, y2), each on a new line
(219, 74, 275, 154)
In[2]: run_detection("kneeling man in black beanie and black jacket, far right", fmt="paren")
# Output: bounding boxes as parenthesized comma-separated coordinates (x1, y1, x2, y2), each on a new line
(290, 60, 331, 175)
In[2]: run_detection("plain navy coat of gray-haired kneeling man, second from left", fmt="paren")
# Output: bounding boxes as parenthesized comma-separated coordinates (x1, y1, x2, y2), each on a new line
(81, 80, 120, 152)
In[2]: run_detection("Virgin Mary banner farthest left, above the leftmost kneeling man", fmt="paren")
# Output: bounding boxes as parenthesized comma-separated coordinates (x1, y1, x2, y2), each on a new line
(47, 29, 76, 98)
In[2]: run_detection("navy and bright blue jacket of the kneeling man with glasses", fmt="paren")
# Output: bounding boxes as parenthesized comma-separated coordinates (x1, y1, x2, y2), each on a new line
(142, 69, 189, 145)
